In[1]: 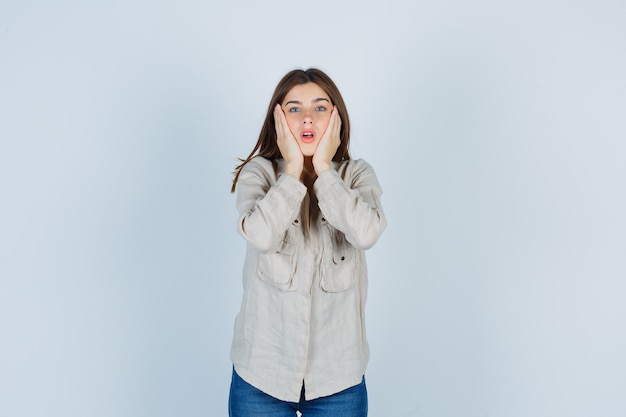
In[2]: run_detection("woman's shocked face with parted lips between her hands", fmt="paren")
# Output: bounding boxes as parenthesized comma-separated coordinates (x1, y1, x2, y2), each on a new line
(281, 83, 333, 156)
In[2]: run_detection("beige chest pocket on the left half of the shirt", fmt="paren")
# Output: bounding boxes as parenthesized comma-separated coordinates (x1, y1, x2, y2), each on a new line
(257, 224, 297, 291)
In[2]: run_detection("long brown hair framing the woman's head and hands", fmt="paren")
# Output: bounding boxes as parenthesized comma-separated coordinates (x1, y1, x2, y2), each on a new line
(230, 68, 350, 193)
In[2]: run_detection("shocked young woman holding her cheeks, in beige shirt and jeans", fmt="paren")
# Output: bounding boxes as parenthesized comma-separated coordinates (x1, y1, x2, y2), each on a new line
(229, 69, 386, 417)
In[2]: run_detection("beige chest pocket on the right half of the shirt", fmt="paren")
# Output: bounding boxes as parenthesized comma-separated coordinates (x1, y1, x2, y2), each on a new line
(320, 226, 358, 292)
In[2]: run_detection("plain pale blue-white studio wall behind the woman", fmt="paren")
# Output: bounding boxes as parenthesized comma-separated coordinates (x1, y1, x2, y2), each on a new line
(0, 0, 626, 417)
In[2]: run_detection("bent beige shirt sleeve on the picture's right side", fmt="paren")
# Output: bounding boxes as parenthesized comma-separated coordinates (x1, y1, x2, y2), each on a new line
(314, 160, 387, 249)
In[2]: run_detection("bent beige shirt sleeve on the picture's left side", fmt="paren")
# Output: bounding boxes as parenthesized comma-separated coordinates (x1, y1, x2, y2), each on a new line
(237, 158, 306, 252)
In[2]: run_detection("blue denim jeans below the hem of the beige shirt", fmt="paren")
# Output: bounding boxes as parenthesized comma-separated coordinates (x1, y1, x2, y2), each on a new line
(228, 369, 367, 417)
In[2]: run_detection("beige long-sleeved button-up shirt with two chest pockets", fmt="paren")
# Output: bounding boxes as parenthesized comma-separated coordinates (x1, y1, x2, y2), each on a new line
(231, 157, 386, 402)
